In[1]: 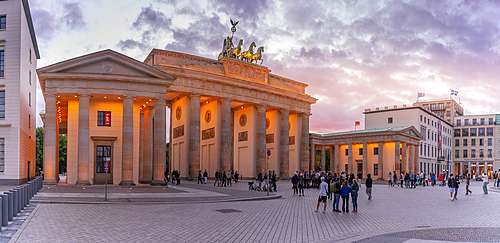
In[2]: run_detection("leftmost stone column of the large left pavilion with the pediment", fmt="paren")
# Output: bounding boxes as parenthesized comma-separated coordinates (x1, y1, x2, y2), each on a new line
(43, 94, 58, 185)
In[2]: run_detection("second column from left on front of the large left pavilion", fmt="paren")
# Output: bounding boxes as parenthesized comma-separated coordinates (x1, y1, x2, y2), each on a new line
(76, 94, 90, 185)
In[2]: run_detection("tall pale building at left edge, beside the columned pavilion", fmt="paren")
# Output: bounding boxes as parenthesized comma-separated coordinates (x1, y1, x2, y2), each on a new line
(0, 0, 40, 184)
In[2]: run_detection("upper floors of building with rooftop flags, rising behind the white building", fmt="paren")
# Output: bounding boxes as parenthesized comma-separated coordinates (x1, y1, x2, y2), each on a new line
(413, 98, 464, 124)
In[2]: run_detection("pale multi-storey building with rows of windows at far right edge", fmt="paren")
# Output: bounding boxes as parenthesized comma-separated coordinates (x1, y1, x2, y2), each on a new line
(453, 114, 500, 177)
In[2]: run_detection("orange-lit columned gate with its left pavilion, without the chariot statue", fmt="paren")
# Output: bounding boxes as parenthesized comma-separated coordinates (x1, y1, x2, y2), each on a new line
(37, 49, 316, 185)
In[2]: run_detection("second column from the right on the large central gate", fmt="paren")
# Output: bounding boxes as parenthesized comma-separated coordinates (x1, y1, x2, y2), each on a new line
(280, 110, 290, 179)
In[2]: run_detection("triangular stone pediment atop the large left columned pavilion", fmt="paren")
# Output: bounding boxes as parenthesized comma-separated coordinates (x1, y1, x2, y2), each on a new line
(38, 50, 175, 80)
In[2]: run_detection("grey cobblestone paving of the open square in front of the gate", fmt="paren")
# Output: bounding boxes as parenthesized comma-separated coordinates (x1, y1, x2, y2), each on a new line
(8, 179, 500, 242)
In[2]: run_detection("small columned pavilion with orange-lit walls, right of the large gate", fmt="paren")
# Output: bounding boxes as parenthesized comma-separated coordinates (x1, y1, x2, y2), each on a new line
(309, 126, 422, 180)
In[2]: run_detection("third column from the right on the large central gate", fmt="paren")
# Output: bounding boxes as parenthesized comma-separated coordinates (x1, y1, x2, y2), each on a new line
(256, 105, 267, 174)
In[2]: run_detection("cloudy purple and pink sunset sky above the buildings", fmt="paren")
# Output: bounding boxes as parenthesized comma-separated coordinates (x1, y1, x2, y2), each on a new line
(29, 0, 500, 133)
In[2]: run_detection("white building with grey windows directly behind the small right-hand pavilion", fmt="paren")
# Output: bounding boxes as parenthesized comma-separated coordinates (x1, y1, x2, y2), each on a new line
(364, 105, 454, 174)
